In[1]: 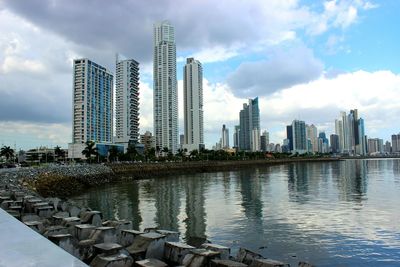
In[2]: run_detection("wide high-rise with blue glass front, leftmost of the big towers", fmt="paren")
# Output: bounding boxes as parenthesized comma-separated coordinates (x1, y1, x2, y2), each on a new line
(68, 58, 113, 158)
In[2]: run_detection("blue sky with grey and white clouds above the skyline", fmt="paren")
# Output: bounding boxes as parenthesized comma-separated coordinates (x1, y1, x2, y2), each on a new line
(0, 0, 400, 149)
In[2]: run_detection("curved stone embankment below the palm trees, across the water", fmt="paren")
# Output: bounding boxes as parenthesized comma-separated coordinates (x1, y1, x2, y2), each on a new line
(0, 158, 341, 198)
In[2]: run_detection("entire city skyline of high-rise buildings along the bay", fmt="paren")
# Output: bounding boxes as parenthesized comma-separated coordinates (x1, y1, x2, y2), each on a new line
(61, 21, 400, 158)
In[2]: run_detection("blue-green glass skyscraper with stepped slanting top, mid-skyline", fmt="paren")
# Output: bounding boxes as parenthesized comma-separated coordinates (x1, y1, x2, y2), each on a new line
(239, 97, 260, 151)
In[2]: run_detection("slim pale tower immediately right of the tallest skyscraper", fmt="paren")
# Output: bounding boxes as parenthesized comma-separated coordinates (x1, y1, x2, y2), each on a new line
(183, 58, 204, 151)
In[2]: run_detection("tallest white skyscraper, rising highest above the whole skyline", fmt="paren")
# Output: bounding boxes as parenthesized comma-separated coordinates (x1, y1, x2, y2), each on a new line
(153, 21, 178, 153)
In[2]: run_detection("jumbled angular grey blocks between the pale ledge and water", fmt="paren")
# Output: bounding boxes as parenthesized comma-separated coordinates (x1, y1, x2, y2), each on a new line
(0, 181, 312, 267)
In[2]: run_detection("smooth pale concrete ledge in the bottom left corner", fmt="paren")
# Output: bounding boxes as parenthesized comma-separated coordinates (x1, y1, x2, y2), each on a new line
(0, 209, 87, 267)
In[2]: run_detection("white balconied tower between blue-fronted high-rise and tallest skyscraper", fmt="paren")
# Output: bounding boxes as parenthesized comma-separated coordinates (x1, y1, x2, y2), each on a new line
(115, 56, 139, 149)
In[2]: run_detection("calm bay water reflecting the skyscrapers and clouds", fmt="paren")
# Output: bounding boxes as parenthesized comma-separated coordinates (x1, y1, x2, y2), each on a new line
(73, 160, 400, 266)
